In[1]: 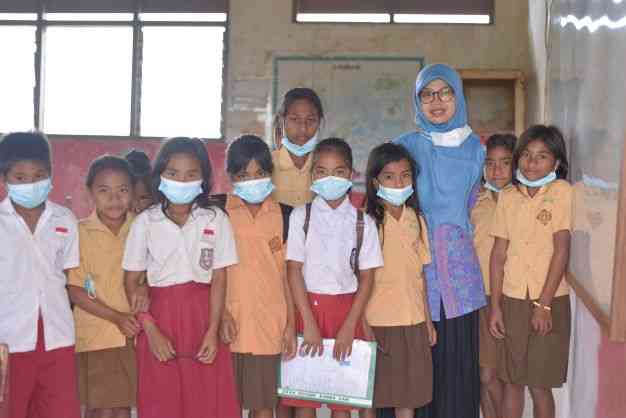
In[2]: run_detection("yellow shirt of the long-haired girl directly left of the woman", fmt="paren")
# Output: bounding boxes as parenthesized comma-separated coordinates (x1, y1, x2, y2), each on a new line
(365, 208, 431, 327)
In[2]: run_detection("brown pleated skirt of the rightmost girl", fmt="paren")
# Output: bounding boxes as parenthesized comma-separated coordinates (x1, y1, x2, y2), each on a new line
(497, 295, 571, 389)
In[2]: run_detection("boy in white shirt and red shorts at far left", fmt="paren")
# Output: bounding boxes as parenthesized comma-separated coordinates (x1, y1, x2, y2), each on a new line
(0, 133, 80, 418)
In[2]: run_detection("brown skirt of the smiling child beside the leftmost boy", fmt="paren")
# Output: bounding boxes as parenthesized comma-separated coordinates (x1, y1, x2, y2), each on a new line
(76, 340, 137, 409)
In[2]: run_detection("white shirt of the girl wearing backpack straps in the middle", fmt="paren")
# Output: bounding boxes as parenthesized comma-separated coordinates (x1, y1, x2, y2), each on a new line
(287, 196, 383, 295)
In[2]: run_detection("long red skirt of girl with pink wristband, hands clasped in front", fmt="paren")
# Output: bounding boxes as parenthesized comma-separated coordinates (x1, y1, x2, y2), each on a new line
(137, 282, 241, 418)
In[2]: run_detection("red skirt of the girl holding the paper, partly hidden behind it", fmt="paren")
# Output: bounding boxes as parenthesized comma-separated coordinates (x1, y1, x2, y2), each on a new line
(281, 293, 365, 411)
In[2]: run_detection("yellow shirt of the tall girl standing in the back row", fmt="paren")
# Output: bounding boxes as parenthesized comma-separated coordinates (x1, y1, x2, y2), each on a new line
(272, 147, 313, 207)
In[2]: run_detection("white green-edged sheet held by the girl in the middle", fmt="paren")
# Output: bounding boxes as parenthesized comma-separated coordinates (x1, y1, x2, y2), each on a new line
(278, 337, 376, 408)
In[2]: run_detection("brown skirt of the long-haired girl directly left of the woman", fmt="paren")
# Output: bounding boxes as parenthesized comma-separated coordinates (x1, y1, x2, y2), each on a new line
(372, 323, 433, 409)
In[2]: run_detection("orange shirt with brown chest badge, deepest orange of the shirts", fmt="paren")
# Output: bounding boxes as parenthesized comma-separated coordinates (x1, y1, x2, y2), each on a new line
(226, 195, 287, 355)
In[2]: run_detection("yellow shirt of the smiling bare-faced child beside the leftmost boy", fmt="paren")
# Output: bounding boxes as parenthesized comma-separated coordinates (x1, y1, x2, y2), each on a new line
(68, 212, 133, 352)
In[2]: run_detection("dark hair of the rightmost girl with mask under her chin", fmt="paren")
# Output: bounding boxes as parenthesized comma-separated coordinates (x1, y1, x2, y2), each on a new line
(513, 125, 569, 179)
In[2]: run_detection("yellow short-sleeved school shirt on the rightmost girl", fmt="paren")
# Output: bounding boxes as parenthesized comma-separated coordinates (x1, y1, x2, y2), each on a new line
(491, 180, 572, 299)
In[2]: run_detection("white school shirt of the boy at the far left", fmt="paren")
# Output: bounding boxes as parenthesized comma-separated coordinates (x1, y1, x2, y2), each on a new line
(0, 197, 80, 353)
